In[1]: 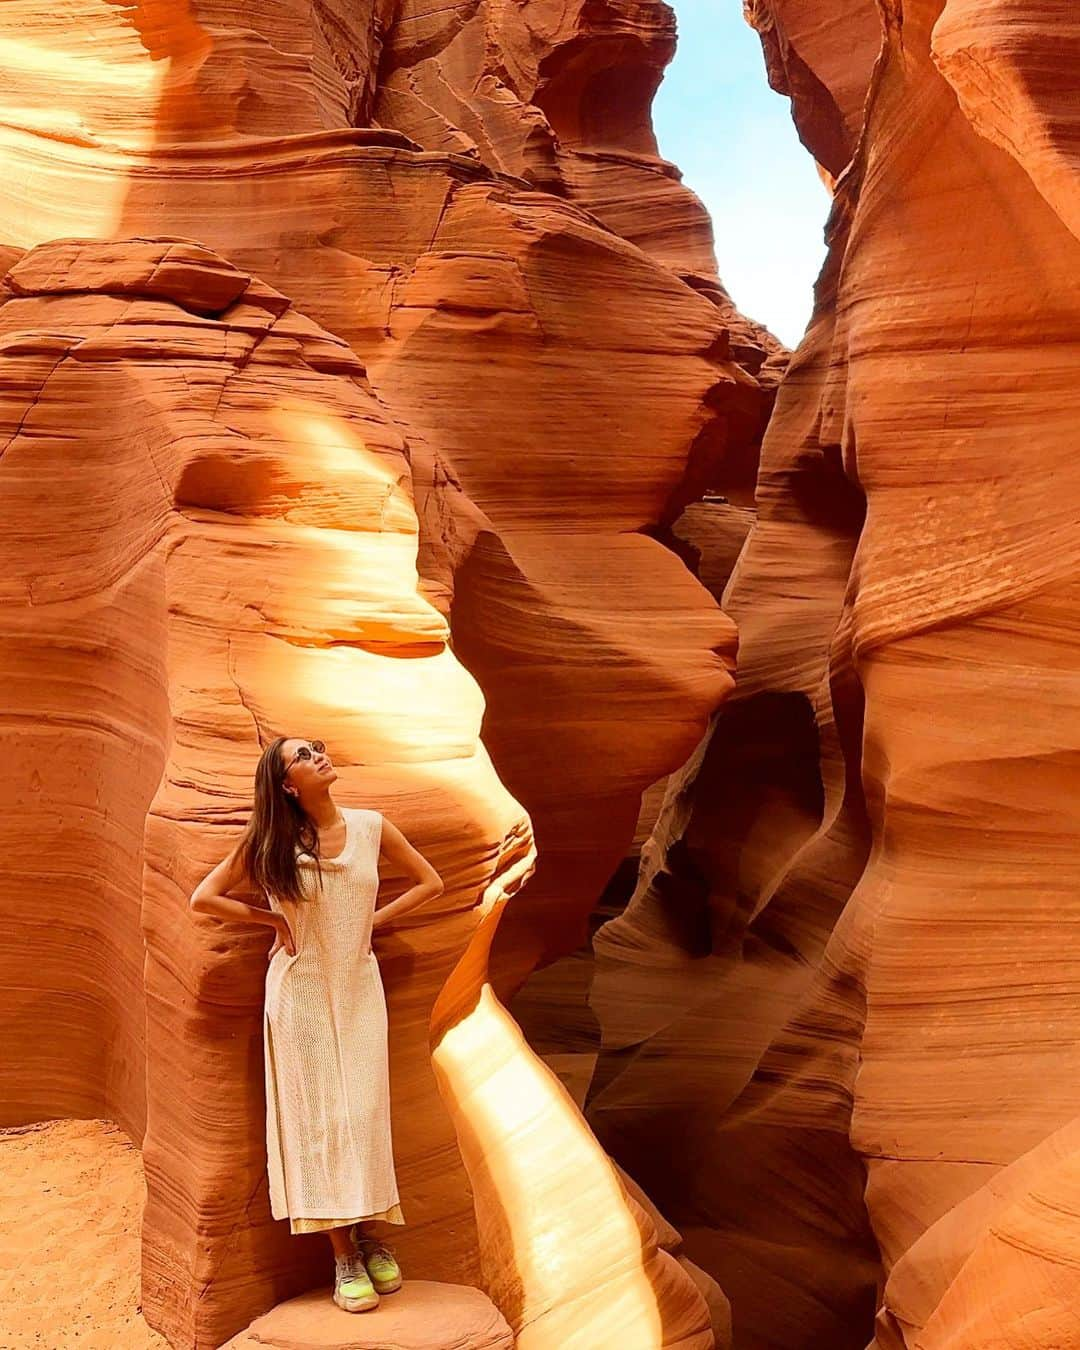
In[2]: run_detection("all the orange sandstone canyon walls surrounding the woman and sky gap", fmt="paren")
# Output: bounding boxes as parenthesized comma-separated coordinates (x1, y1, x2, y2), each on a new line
(0, 0, 1080, 1350)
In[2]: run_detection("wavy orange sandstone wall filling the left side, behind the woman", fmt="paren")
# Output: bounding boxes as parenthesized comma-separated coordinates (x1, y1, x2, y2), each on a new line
(0, 0, 778, 1347)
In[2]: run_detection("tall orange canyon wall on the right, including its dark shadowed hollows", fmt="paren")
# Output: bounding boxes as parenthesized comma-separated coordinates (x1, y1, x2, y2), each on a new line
(587, 0, 1080, 1350)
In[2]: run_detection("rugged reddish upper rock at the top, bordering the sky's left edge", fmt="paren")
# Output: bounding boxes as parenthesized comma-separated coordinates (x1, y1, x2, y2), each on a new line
(374, 0, 716, 277)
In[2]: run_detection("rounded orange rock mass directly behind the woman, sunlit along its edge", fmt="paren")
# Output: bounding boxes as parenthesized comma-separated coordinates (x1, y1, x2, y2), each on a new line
(0, 240, 711, 1346)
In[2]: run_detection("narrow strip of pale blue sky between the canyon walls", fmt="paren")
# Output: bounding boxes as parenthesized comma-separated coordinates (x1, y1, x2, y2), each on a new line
(652, 0, 829, 347)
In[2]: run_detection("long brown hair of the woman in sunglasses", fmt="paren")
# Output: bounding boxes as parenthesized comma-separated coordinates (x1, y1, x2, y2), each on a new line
(238, 736, 323, 900)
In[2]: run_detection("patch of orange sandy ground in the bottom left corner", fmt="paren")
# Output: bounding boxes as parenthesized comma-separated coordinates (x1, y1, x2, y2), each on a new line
(0, 1121, 167, 1350)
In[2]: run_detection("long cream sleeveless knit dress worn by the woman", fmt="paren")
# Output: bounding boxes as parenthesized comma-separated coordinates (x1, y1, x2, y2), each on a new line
(263, 806, 405, 1233)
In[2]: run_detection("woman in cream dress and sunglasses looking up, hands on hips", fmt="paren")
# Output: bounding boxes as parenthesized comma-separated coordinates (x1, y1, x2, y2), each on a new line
(190, 736, 443, 1312)
